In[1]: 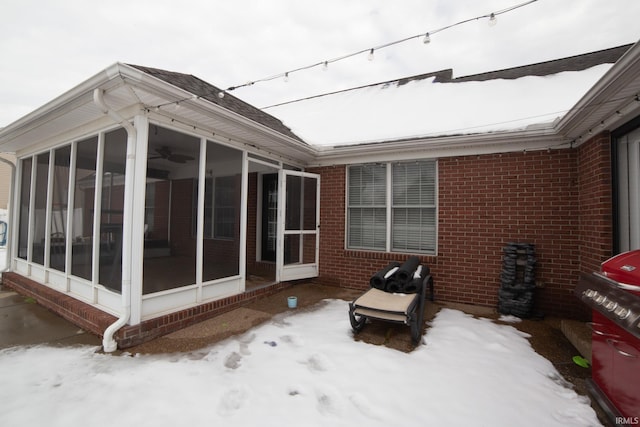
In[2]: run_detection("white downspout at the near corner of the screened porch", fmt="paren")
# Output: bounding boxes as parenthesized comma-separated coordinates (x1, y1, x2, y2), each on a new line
(93, 89, 137, 353)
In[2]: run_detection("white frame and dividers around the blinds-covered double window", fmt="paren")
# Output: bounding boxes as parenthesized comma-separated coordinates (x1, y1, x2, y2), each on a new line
(344, 159, 438, 255)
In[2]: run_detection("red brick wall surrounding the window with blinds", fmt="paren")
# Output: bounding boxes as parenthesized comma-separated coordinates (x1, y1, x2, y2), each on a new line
(312, 141, 611, 318)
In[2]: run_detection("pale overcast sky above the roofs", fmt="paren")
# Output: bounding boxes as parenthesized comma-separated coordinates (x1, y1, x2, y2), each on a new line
(0, 0, 640, 127)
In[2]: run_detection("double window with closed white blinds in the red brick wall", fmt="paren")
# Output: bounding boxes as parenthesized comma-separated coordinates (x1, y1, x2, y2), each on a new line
(347, 160, 436, 253)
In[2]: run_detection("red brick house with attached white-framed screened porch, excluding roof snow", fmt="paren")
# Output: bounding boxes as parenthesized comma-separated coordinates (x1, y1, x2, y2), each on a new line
(0, 44, 640, 351)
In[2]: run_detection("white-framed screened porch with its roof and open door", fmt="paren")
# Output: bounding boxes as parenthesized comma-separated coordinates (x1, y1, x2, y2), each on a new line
(0, 64, 320, 348)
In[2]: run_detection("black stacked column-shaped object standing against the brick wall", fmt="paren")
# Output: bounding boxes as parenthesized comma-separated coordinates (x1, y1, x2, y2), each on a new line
(498, 243, 536, 318)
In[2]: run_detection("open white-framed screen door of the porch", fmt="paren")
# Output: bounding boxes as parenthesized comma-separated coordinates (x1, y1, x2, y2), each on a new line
(276, 169, 320, 282)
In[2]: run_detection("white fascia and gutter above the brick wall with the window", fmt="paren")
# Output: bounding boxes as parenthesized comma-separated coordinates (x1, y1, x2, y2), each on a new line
(310, 127, 571, 166)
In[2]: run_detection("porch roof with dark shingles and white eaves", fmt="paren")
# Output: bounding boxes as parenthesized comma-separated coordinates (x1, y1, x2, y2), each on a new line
(0, 63, 314, 165)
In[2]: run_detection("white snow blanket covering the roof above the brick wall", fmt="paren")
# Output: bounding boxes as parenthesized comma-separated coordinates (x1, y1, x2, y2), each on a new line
(265, 63, 612, 146)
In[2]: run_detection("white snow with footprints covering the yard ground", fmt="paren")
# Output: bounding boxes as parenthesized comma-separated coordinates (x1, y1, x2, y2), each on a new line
(0, 300, 600, 427)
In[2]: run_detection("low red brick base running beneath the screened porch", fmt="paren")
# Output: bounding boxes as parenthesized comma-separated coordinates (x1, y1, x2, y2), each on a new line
(2, 272, 292, 349)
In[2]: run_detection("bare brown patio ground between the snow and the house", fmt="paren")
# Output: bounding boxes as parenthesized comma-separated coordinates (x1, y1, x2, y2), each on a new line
(0, 283, 606, 423)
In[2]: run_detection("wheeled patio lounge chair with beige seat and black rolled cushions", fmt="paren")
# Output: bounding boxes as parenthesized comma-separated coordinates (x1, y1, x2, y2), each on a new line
(349, 257, 433, 344)
